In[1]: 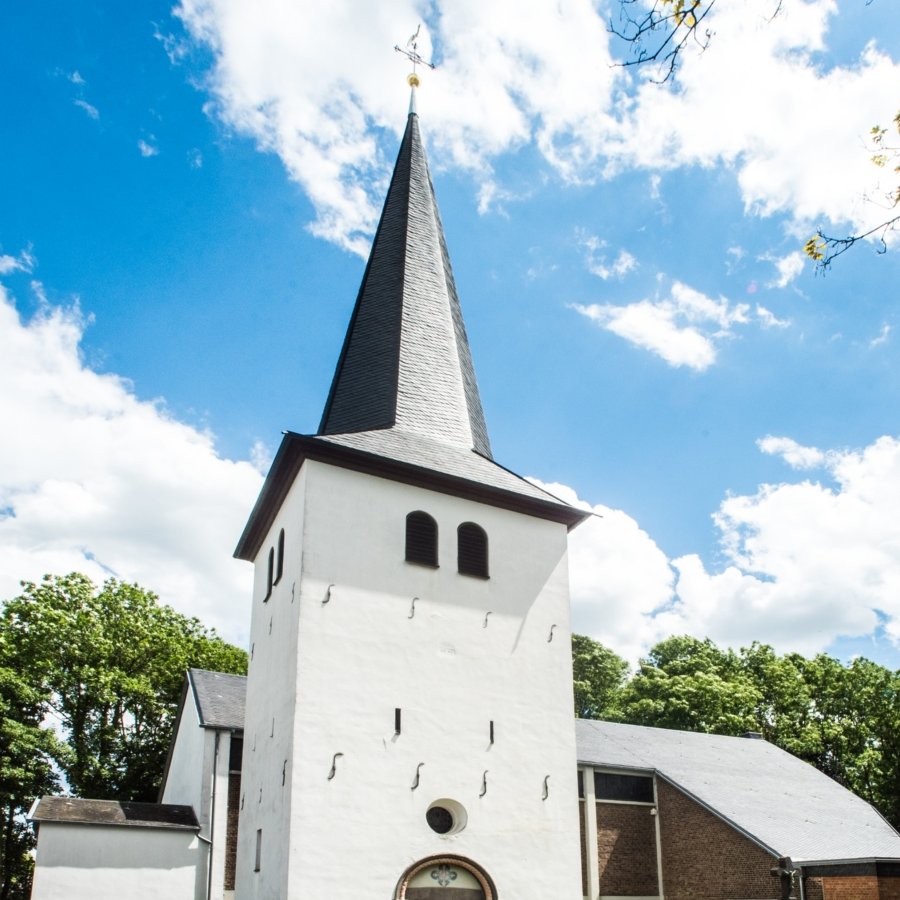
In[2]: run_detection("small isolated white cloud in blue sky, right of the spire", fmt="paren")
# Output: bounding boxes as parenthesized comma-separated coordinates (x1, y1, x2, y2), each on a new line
(573, 281, 749, 372)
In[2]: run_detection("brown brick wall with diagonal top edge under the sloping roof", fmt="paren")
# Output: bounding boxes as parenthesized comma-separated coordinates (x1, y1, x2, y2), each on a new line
(657, 779, 780, 900)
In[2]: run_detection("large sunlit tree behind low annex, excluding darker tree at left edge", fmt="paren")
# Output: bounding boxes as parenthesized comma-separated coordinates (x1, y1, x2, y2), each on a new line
(0, 573, 247, 800)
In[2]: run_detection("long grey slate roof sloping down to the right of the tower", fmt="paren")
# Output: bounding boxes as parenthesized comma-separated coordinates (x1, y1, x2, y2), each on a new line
(575, 719, 900, 863)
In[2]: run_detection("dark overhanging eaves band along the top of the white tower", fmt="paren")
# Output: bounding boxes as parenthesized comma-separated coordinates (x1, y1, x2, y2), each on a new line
(234, 431, 591, 562)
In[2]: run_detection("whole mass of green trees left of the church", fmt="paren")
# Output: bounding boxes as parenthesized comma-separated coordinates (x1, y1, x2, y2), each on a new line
(0, 573, 247, 900)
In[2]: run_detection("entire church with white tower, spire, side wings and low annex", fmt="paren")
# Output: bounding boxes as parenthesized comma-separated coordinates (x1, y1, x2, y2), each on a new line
(24, 76, 900, 900)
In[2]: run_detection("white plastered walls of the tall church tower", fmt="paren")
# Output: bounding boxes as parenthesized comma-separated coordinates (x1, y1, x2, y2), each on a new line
(237, 461, 581, 900)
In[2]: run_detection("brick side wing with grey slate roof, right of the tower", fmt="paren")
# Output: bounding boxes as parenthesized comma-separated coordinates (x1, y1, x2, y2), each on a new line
(576, 720, 900, 900)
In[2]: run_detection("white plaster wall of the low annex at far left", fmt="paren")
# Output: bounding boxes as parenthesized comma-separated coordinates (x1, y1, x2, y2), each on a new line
(31, 822, 206, 900)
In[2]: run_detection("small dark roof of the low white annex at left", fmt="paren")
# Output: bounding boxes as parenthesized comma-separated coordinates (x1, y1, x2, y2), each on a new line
(29, 797, 200, 831)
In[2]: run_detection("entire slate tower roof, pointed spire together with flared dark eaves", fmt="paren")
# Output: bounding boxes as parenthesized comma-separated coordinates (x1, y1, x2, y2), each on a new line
(235, 95, 588, 560)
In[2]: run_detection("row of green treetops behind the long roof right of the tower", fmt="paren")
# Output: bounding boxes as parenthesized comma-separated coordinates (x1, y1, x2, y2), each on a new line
(572, 635, 900, 827)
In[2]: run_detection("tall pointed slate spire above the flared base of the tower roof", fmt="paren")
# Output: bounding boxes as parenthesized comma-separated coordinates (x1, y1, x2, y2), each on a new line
(318, 103, 491, 458)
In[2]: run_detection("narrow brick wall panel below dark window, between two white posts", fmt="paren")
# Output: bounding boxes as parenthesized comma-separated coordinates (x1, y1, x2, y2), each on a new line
(597, 803, 659, 897)
